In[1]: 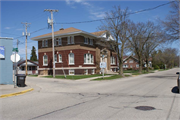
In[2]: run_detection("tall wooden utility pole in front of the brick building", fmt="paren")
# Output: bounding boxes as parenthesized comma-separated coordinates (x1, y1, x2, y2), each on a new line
(44, 9, 59, 77)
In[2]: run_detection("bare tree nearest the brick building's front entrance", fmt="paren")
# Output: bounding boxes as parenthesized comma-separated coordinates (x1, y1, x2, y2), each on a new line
(99, 6, 129, 76)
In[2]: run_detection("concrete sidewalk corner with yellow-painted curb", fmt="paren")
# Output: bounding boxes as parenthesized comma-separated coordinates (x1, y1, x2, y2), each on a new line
(0, 85, 33, 98)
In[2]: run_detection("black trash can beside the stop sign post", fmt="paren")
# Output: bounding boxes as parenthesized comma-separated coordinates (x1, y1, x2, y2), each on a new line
(16, 74, 26, 87)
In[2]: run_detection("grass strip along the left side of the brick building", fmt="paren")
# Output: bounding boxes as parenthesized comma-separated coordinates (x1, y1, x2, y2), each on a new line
(44, 74, 105, 80)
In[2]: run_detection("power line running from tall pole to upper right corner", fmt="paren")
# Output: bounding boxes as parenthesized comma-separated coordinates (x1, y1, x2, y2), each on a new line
(55, 1, 174, 24)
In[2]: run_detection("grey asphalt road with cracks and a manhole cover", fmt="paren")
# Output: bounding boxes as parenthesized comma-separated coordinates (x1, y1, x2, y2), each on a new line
(0, 68, 180, 120)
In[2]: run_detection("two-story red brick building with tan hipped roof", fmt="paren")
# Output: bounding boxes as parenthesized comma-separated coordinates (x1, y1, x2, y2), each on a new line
(31, 27, 117, 75)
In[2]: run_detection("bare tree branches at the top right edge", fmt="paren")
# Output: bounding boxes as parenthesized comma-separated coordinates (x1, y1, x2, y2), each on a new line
(161, 0, 180, 41)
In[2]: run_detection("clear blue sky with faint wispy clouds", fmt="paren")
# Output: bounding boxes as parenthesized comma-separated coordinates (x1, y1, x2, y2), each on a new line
(0, 0, 178, 59)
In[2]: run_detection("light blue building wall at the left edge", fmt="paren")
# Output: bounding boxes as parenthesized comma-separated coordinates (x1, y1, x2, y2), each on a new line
(0, 37, 13, 84)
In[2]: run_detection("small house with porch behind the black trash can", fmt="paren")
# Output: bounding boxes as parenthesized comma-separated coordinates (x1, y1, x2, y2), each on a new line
(17, 60, 38, 75)
